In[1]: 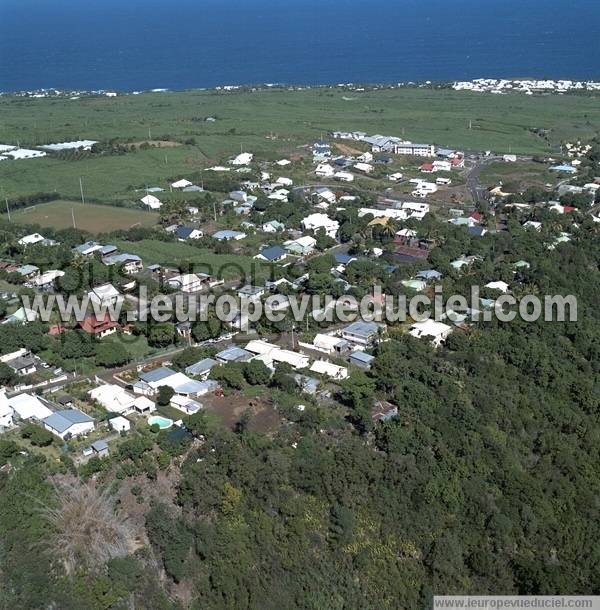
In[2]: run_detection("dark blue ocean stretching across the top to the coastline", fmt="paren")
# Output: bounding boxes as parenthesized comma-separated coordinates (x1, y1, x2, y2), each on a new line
(0, 0, 600, 91)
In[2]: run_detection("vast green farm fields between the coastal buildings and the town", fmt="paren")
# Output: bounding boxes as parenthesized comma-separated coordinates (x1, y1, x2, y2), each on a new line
(0, 88, 600, 200)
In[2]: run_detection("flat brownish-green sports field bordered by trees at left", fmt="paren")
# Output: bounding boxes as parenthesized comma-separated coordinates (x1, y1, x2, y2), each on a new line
(3, 201, 158, 233)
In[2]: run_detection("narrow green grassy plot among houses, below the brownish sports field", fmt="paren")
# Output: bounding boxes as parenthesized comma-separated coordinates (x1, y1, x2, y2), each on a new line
(115, 239, 269, 283)
